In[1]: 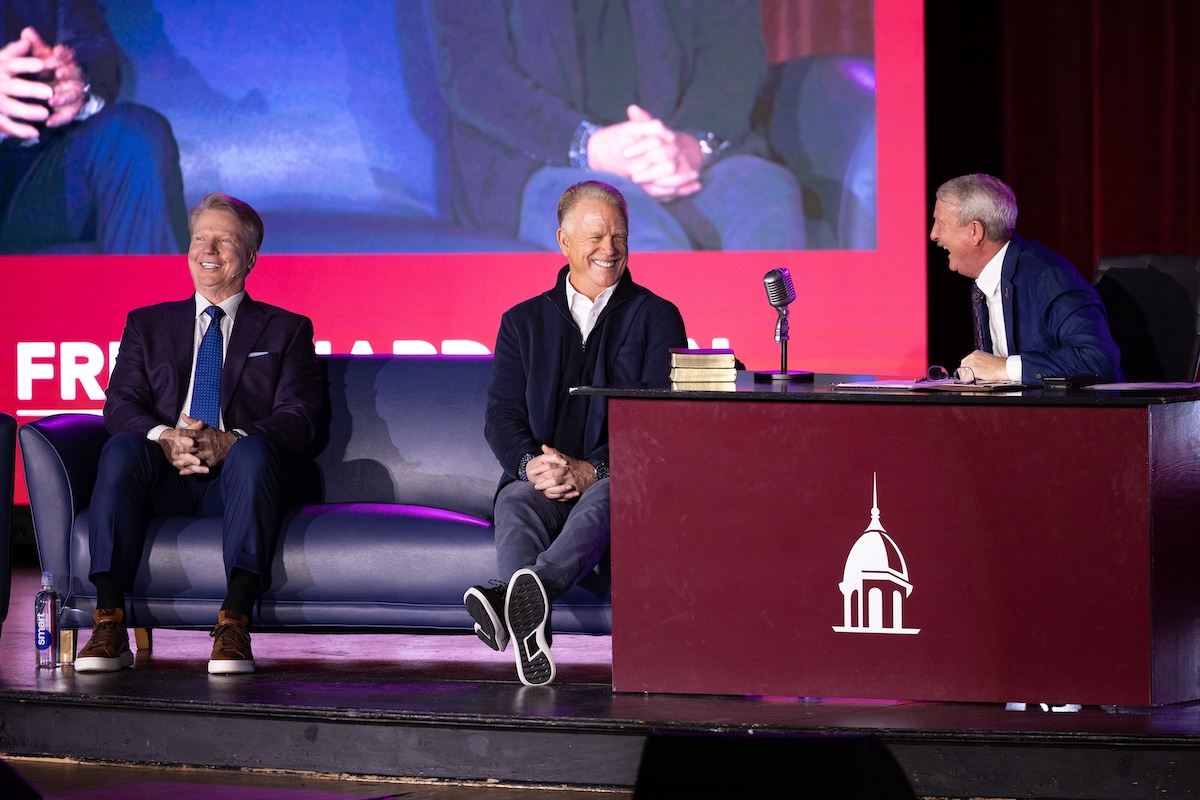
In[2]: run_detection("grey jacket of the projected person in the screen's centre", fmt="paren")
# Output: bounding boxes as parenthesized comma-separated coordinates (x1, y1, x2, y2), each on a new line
(431, 0, 767, 235)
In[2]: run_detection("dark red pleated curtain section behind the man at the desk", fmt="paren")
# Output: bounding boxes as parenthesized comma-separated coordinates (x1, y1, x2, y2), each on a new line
(1001, 0, 1200, 277)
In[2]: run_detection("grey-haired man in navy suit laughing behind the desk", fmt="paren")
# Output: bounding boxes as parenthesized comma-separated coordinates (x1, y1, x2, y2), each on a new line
(929, 174, 1122, 384)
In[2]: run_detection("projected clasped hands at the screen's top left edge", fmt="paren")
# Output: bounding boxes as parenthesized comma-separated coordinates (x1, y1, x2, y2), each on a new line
(0, 28, 88, 139)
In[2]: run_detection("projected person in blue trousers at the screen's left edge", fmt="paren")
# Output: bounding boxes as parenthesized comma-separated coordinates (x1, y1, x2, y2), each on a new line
(0, 0, 187, 253)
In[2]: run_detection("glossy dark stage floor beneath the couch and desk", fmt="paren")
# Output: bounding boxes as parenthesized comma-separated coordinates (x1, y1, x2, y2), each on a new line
(0, 567, 1200, 799)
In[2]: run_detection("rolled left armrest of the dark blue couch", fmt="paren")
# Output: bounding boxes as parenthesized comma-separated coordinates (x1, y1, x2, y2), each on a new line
(18, 414, 108, 587)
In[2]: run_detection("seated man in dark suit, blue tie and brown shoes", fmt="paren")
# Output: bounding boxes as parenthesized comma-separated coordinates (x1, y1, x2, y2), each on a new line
(76, 194, 322, 674)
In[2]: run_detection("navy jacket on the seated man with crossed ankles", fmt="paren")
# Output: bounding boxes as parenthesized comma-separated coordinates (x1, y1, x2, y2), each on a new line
(484, 266, 688, 486)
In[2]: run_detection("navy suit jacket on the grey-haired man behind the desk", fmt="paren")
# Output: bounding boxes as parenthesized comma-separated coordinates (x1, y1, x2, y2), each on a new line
(1000, 236, 1122, 383)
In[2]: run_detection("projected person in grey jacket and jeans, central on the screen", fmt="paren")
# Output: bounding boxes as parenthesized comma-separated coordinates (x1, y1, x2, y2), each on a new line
(431, 0, 804, 251)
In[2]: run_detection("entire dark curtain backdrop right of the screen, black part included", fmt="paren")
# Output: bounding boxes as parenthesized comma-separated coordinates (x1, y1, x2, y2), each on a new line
(924, 0, 1200, 363)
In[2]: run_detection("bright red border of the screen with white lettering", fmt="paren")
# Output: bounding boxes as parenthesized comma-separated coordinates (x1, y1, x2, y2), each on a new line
(0, 0, 928, 503)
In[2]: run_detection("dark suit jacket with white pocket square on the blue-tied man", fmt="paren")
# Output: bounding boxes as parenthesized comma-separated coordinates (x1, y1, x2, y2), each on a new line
(104, 295, 322, 452)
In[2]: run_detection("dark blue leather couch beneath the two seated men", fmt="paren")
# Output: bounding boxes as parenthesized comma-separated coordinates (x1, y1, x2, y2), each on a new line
(19, 356, 612, 652)
